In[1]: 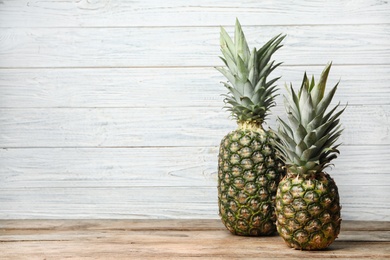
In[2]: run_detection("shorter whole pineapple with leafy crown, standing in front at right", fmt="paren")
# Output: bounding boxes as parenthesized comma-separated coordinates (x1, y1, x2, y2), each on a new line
(275, 63, 345, 250)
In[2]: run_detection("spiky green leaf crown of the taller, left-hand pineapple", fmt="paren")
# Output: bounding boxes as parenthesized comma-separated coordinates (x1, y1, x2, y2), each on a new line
(216, 19, 285, 125)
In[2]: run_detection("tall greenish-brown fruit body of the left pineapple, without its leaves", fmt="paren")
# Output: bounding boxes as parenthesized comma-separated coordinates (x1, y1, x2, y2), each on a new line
(218, 127, 284, 236)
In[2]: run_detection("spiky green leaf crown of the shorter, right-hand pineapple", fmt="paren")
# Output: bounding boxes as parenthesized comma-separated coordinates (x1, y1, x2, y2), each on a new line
(276, 63, 345, 176)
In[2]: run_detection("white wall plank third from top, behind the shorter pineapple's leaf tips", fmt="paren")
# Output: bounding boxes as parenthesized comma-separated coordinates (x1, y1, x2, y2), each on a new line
(0, 64, 390, 108)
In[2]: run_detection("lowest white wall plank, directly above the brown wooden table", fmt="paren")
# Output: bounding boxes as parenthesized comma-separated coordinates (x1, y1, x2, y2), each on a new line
(0, 184, 390, 221)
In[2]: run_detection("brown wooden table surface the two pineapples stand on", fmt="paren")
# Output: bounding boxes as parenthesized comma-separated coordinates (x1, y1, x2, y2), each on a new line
(0, 220, 390, 259)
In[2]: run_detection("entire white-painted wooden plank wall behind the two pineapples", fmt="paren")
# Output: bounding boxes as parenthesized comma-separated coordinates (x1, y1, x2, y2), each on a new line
(0, 0, 390, 221)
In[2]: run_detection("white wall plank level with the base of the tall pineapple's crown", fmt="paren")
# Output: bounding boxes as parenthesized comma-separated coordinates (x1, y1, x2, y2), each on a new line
(0, 105, 390, 148)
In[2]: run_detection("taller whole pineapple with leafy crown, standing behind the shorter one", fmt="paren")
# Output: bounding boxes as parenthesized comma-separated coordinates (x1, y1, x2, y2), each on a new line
(217, 20, 284, 236)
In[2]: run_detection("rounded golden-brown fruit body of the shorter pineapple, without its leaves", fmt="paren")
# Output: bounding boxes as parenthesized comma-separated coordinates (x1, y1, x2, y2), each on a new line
(275, 172, 341, 250)
